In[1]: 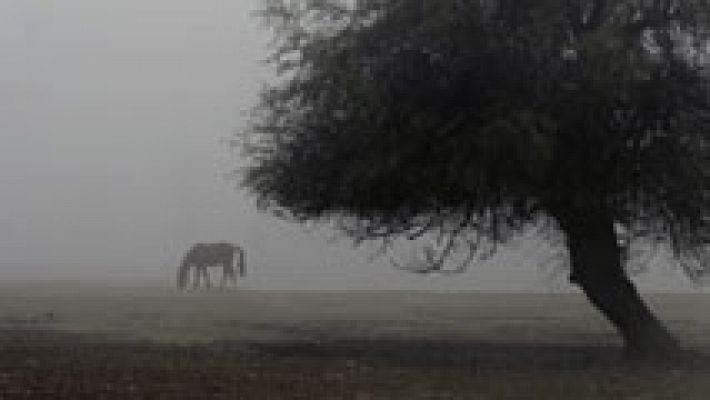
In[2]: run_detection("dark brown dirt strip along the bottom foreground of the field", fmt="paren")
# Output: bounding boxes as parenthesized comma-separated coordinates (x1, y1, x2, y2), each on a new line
(0, 329, 710, 400)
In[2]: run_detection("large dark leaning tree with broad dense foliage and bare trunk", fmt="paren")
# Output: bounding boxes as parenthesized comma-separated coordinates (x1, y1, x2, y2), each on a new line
(244, 0, 710, 356)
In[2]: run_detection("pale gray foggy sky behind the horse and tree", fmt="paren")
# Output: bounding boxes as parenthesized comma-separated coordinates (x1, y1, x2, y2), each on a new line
(0, 0, 700, 290)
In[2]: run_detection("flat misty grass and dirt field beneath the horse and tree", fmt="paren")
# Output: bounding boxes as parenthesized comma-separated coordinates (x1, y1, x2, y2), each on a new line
(0, 284, 710, 399)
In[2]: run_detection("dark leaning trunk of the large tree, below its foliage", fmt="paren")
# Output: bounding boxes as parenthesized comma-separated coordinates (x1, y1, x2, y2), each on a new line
(557, 212, 680, 359)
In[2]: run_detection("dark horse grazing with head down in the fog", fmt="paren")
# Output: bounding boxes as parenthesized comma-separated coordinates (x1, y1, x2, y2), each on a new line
(178, 242, 246, 289)
